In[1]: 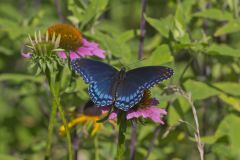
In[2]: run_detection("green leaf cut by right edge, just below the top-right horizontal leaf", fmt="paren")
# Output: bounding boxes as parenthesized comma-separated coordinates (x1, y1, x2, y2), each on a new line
(214, 20, 240, 36)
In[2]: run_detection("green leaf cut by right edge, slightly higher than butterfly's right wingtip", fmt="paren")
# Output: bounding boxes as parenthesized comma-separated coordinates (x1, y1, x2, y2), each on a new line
(207, 44, 240, 57)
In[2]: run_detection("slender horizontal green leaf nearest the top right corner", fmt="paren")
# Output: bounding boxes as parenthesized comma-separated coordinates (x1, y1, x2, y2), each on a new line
(194, 8, 233, 21)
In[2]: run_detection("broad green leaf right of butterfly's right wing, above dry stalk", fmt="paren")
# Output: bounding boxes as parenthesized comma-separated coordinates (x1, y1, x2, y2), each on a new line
(184, 80, 220, 100)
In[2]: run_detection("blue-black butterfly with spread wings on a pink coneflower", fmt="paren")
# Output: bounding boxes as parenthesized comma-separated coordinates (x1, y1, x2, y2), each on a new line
(71, 58, 173, 111)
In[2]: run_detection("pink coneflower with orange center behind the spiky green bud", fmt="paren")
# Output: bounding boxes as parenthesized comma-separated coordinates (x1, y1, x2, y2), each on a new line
(21, 24, 105, 59)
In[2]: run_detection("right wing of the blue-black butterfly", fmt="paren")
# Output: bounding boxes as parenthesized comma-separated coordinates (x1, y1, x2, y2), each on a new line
(115, 66, 173, 111)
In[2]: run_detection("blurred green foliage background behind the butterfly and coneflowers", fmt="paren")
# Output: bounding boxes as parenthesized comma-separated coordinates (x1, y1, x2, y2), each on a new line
(0, 0, 240, 160)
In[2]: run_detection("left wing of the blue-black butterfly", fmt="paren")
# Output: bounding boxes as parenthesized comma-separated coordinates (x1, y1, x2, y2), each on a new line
(71, 58, 118, 106)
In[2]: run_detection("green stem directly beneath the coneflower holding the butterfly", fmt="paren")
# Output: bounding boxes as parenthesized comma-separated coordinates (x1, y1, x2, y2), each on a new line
(117, 112, 127, 160)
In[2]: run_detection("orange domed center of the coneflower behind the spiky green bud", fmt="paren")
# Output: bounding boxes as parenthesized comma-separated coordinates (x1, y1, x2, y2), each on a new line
(48, 24, 83, 51)
